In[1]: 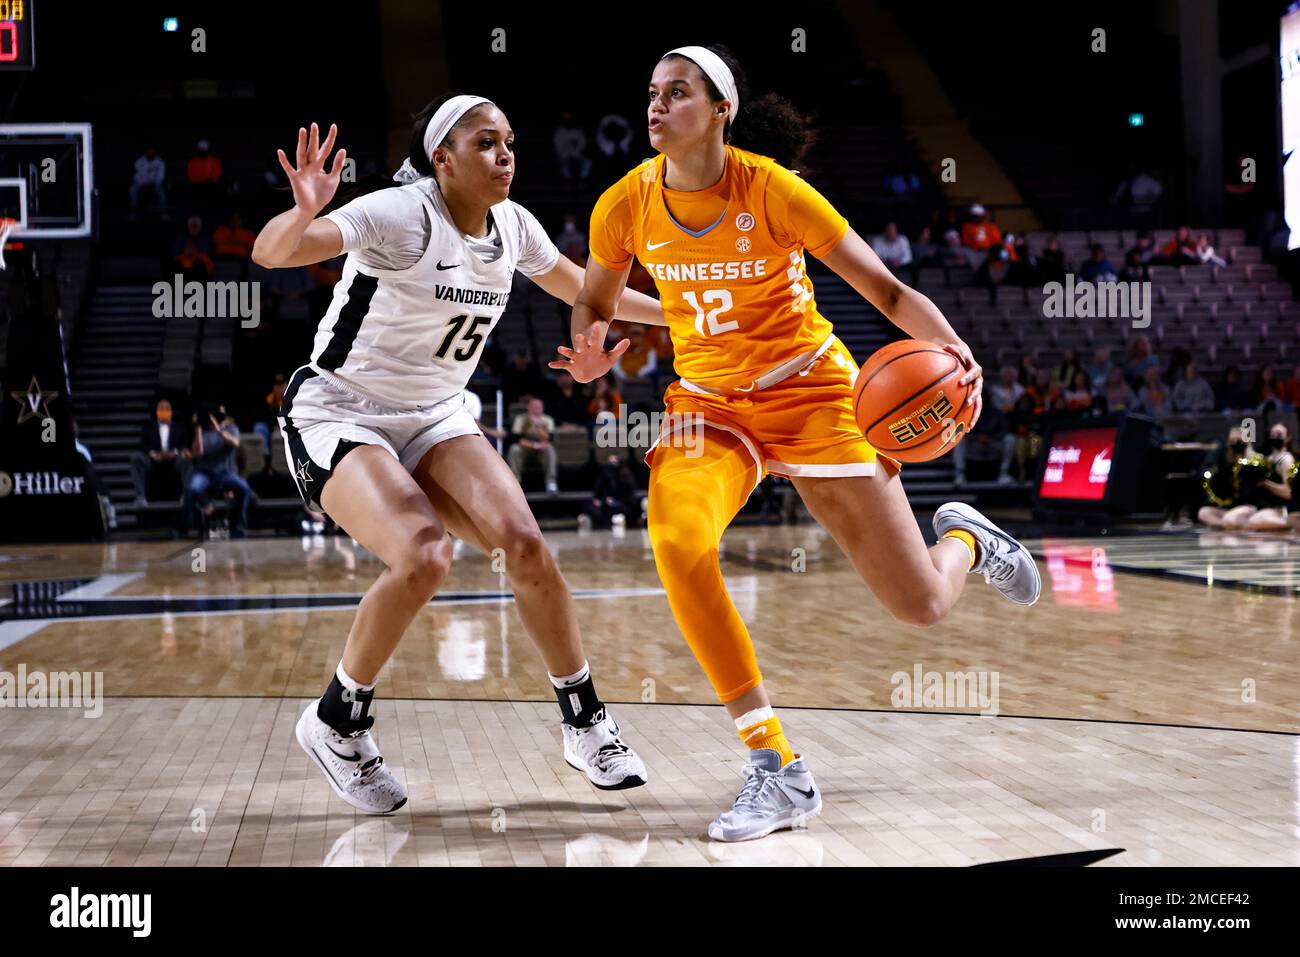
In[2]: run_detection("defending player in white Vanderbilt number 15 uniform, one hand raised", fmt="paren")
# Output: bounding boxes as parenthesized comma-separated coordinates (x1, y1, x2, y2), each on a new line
(252, 95, 664, 813)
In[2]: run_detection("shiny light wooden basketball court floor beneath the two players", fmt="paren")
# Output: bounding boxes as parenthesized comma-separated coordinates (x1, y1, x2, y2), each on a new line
(0, 525, 1300, 866)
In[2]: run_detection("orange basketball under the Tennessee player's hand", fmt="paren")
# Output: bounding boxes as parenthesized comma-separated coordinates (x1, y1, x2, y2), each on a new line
(853, 339, 975, 462)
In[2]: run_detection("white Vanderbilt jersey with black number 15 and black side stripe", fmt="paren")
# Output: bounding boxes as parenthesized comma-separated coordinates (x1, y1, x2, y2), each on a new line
(311, 178, 560, 408)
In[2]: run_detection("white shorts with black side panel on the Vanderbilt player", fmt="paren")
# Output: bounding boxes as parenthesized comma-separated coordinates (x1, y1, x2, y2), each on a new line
(280, 365, 482, 511)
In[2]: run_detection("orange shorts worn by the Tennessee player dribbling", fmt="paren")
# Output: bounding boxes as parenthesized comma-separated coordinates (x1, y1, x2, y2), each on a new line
(645, 339, 898, 485)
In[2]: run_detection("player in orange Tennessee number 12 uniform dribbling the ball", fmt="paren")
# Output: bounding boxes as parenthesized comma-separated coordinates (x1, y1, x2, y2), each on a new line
(551, 47, 1040, 841)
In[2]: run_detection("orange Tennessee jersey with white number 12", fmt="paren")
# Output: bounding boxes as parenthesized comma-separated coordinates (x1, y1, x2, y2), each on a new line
(590, 147, 849, 391)
